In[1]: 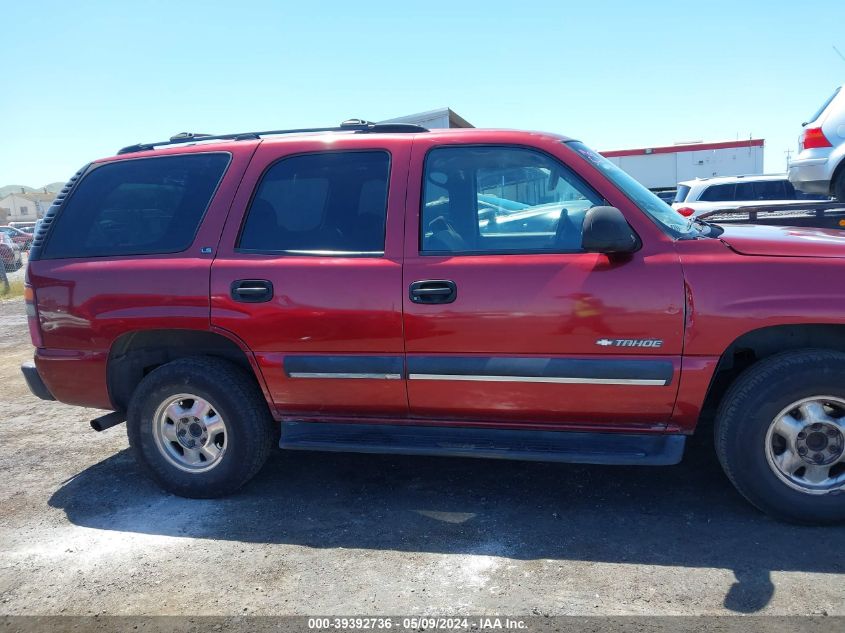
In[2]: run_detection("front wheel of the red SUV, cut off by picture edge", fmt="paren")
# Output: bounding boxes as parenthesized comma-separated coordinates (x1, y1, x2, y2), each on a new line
(715, 350, 845, 525)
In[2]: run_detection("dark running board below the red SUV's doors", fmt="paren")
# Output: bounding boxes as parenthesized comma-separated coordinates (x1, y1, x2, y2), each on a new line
(279, 422, 686, 466)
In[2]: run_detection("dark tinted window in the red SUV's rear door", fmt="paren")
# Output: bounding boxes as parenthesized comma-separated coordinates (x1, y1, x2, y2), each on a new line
(238, 151, 390, 255)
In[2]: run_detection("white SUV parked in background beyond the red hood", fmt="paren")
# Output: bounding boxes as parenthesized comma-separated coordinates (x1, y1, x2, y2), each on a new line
(672, 174, 828, 217)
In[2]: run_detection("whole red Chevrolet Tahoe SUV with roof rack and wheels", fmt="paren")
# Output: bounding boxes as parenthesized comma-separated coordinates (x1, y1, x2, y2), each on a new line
(18, 122, 845, 522)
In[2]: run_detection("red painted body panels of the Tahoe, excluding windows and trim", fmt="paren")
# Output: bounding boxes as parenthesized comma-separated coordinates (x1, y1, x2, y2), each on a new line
(24, 130, 845, 432)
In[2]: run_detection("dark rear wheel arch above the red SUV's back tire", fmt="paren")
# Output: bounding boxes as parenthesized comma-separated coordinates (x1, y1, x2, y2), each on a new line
(106, 329, 273, 411)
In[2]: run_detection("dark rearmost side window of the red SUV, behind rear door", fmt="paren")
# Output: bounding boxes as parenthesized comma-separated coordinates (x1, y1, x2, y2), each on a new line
(44, 153, 230, 258)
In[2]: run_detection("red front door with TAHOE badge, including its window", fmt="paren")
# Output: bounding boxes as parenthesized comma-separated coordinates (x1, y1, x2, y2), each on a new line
(404, 138, 684, 430)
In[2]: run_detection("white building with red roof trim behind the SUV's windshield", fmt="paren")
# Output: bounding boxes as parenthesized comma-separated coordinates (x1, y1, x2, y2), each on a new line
(601, 138, 764, 191)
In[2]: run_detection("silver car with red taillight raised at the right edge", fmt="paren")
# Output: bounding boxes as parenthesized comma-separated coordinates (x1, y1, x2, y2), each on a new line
(789, 86, 845, 202)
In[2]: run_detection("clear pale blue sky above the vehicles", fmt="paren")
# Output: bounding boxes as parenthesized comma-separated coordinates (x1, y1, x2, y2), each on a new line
(0, 0, 845, 186)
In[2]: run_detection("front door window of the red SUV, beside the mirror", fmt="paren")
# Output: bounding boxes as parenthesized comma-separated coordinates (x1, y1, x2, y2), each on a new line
(420, 147, 603, 253)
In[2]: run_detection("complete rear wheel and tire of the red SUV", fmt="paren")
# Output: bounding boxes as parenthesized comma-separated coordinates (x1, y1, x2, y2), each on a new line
(126, 356, 274, 498)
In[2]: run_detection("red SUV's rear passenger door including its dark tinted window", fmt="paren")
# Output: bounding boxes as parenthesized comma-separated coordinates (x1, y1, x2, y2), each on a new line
(211, 135, 409, 418)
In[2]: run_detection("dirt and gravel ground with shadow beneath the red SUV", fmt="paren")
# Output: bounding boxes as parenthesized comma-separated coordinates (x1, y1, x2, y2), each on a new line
(0, 300, 845, 615)
